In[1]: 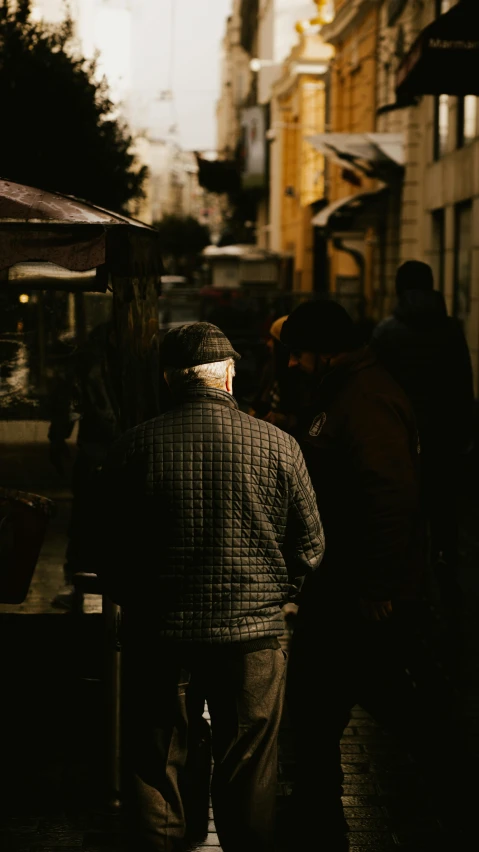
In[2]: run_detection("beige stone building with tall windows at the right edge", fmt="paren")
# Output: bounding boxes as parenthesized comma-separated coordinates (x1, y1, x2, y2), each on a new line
(377, 0, 479, 391)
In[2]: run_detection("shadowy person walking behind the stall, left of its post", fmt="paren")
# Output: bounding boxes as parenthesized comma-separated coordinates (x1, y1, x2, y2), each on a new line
(48, 321, 121, 611)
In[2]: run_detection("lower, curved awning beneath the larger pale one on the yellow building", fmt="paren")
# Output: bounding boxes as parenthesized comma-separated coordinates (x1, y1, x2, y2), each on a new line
(311, 186, 388, 231)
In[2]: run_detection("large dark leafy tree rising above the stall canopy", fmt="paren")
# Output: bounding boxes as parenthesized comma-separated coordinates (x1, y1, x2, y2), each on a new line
(0, 0, 146, 211)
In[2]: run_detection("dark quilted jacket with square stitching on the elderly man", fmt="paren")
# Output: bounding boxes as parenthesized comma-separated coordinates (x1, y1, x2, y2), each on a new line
(98, 387, 324, 642)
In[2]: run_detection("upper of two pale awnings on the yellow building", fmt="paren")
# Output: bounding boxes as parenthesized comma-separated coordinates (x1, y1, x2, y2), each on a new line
(306, 133, 405, 179)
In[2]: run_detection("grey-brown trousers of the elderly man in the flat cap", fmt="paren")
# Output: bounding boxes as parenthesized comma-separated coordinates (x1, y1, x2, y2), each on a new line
(125, 643, 285, 852)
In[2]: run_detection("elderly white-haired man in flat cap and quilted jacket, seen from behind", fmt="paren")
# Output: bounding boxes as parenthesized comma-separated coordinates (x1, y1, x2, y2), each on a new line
(98, 322, 324, 852)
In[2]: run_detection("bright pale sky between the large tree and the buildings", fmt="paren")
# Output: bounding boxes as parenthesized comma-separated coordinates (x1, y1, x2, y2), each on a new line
(34, 0, 232, 151)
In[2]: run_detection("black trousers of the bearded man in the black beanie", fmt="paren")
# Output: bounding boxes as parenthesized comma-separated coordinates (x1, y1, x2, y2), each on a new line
(287, 596, 460, 834)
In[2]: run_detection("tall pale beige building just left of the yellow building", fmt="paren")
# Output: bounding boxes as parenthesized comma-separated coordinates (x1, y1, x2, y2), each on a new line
(217, 0, 324, 250)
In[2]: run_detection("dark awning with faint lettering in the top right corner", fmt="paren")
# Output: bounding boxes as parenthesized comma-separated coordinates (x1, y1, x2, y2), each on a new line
(396, 0, 479, 98)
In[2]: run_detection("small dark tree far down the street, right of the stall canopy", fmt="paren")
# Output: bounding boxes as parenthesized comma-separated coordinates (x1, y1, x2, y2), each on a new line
(155, 215, 211, 275)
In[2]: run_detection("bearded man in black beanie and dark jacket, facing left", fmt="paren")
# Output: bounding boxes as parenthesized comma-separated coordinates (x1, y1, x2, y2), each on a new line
(281, 300, 464, 852)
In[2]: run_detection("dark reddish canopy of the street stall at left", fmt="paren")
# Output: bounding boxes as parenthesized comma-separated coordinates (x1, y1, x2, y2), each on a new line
(0, 179, 163, 277)
